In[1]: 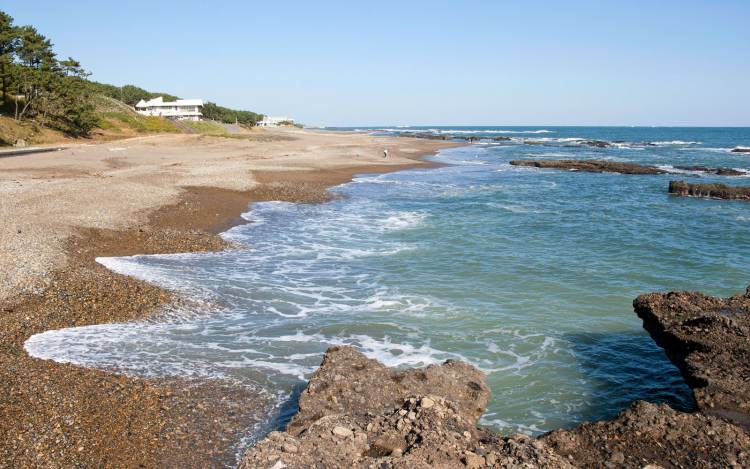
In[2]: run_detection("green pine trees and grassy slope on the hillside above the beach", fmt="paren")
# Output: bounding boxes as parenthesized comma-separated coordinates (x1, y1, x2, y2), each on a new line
(0, 11, 263, 144)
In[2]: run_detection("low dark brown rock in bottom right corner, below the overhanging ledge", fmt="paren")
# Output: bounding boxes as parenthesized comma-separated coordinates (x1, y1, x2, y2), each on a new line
(540, 401, 750, 469)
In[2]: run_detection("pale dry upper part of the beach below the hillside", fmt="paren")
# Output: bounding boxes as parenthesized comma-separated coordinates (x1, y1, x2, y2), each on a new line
(0, 130, 446, 302)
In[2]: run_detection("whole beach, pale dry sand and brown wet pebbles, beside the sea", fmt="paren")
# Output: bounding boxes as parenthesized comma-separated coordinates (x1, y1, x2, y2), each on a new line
(0, 129, 455, 467)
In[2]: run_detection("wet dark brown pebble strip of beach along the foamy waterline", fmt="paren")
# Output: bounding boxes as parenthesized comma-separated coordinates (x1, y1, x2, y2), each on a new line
(0, 129, 457, 467)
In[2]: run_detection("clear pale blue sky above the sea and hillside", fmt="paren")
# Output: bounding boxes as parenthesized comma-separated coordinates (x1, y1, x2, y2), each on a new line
(5, 0, 750, 126)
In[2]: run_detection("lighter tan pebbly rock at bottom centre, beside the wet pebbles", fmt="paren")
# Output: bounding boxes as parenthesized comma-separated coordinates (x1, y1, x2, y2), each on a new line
(240, 347, 573, 469)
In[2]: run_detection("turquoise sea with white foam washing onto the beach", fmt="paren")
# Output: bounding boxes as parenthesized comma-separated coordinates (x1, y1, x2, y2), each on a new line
(27, 127, 750, 442)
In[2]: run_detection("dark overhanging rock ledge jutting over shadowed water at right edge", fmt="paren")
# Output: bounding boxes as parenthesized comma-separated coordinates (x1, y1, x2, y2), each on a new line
(633, 286, 750, 428)
